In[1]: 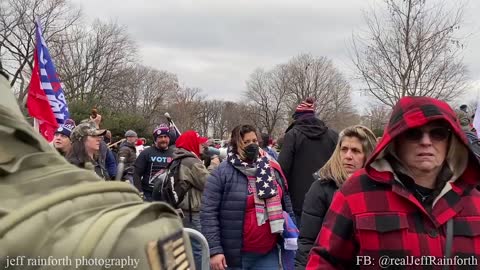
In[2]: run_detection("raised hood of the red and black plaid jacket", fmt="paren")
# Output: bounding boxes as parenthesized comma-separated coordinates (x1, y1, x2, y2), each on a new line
(365, 97, 480, 188)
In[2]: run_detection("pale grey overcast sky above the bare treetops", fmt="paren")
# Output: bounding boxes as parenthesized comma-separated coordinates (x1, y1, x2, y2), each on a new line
(70, 0, 480, 109)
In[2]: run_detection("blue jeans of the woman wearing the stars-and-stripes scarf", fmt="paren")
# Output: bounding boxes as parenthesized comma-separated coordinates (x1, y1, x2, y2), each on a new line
(233, 247, 280, 270)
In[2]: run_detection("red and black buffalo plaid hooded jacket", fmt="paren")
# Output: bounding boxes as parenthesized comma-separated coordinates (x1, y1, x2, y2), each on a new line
(307, 97, 480, 269)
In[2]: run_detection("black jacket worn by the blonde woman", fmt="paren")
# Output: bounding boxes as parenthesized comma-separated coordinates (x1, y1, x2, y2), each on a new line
(295, 174, 338, 270)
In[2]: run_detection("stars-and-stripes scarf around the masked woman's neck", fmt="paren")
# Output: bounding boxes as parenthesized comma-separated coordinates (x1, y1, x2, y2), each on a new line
(227, 151, 285, 233)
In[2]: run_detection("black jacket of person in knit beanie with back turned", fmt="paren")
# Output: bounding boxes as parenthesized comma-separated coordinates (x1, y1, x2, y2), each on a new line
(278, 117, 338, 215)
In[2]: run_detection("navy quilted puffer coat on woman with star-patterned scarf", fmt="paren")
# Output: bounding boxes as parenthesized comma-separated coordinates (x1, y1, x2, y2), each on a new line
(200, 158, 295, 268)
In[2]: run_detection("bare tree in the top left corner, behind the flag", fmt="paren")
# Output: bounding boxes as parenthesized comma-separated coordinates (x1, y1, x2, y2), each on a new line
(0, 0, 80, 101)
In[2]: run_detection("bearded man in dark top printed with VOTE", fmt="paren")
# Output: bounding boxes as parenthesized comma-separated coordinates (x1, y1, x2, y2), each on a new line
(133, 124, 174, 201)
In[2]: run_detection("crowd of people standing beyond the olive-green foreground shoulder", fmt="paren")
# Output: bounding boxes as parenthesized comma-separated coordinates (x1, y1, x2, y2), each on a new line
(47, 97, 480, 270)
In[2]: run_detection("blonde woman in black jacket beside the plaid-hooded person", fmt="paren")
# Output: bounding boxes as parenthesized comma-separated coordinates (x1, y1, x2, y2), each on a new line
(295, 125, 377, 269)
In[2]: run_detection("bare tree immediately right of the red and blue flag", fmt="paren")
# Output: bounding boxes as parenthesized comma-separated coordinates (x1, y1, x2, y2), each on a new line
(53, 20, 137, 103)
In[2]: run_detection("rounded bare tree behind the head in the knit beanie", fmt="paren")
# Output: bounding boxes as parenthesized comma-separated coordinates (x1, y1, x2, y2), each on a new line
(244, 54, 352, 137)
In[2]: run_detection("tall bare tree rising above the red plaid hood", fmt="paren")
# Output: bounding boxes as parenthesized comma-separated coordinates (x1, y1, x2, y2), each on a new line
(352, 0, 467, 107)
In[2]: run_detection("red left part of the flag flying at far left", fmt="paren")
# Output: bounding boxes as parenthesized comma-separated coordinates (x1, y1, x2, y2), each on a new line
(27, 40, 58, 142)
